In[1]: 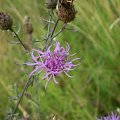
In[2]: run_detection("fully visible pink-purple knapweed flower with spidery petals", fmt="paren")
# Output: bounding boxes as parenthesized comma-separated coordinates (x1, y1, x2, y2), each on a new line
(26, 42, 79, 88)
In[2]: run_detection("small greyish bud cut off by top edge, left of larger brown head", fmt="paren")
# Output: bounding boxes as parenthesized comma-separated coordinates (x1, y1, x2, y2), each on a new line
(45, 0, 58, 9)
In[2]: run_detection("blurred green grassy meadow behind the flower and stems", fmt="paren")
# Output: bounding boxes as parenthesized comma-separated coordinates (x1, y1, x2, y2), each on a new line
(0, 0, 120, 120)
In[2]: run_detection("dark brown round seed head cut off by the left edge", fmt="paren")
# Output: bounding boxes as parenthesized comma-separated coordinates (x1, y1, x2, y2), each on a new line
(0, 12, 13, 30)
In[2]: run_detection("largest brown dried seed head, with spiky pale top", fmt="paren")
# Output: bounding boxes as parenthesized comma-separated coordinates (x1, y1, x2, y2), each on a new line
(57, 2, 76, 23)
